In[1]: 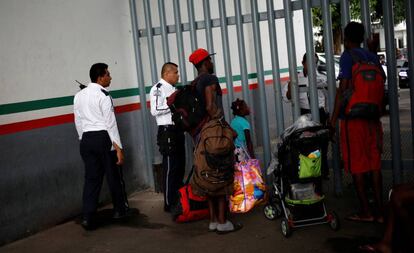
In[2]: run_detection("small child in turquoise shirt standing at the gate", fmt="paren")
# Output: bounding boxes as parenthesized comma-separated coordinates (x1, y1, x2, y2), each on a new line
(230, 99, 255, 161)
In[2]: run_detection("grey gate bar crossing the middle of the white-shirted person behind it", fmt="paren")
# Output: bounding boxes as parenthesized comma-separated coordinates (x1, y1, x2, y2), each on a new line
(302, 0, 320, 121)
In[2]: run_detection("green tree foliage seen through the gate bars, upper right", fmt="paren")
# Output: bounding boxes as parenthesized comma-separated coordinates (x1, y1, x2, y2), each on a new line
(312, 0, 405, 54)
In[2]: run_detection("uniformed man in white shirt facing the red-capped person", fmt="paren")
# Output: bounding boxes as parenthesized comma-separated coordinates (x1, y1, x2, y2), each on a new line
(150, 62, 185, 212)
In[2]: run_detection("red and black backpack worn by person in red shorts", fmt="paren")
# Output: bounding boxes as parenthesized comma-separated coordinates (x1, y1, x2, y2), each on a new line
(341, 51, 384, 119)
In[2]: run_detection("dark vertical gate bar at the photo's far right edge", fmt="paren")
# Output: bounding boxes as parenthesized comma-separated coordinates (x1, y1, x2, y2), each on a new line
(405, 0, 414, 154)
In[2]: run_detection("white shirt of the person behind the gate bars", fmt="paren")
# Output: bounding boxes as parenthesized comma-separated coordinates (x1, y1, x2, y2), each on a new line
(282, 71, 327, 110)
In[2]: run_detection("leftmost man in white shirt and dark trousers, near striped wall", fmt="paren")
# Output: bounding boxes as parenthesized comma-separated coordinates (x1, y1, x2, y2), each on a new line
(73, 63, 129, 230)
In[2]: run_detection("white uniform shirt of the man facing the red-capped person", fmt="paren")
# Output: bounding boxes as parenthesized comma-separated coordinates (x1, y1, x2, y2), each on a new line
(150, 79, 176, 126)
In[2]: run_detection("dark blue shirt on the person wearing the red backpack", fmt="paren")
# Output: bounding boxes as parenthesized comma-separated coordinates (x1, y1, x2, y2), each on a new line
(338, 48, 379, 79)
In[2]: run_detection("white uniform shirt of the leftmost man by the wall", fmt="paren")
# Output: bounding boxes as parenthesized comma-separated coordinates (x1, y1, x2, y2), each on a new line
(73, 83, 122, 149)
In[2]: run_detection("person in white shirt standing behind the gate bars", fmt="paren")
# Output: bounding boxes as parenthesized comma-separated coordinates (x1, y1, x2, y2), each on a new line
(282, 53, 329, 179)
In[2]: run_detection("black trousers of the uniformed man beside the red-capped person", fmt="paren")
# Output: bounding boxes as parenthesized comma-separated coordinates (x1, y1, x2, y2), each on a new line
(157, 125, 185, 210)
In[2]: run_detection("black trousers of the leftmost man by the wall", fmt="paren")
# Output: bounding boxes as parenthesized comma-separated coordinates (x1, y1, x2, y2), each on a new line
(80, 131, 128, 218)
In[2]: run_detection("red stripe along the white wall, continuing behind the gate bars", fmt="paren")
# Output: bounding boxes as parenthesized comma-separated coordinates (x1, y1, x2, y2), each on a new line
(0, 77, 289, 135)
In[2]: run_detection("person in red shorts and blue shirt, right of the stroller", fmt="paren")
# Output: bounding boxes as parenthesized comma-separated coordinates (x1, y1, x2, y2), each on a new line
(330, 22, 383, 222)
